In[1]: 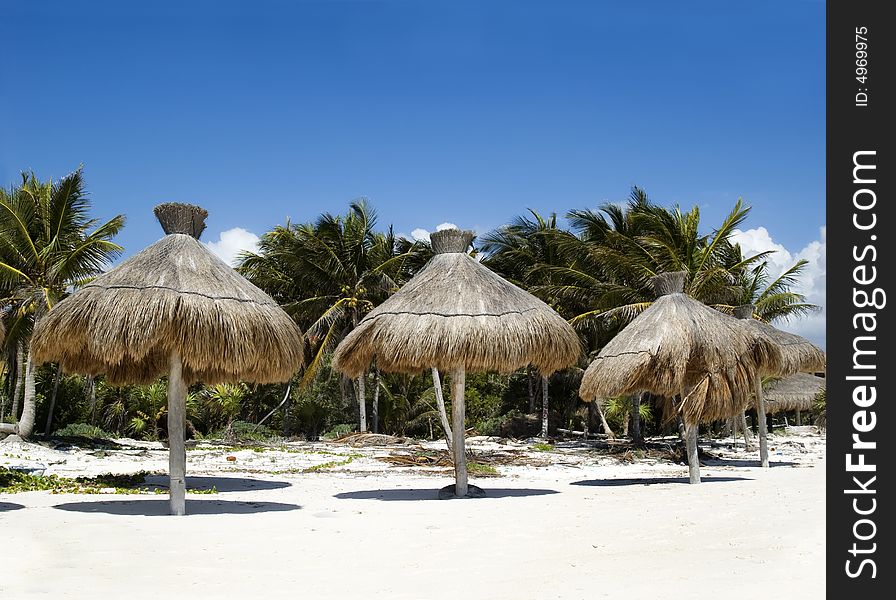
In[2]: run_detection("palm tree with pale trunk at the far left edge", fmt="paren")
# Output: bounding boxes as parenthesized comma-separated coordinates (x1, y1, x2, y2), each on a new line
(0, 168, 124, 437)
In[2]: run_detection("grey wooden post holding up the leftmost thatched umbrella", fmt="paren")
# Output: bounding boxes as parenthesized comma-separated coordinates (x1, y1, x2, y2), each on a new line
(168, 352, 187, 515)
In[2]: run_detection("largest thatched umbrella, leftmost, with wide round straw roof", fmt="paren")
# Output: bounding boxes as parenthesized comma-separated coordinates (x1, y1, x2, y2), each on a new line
(31, 203, 304, 515)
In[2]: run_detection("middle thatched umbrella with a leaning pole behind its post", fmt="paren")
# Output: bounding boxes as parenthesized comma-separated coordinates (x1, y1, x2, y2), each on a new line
(333, 229, 581, 497)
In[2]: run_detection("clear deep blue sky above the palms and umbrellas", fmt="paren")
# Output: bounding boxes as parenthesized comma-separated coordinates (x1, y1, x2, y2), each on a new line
(0, 0, 825, 343)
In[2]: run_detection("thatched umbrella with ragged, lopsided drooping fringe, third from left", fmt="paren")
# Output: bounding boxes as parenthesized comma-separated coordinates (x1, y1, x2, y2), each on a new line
(579, 271, 780, 483)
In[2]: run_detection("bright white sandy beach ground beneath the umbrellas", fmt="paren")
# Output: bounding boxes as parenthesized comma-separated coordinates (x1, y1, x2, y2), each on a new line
(0, 428, 825, 600)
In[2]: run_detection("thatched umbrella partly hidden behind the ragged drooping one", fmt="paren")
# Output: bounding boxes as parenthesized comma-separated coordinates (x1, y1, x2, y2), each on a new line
(734, 304, 826, 467)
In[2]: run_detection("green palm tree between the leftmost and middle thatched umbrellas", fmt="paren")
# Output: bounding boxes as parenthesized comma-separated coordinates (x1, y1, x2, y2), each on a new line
(237, 200, 425, 431)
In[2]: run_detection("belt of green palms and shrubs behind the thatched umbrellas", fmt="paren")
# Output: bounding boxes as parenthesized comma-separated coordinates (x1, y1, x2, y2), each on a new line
(0, 169, 814, 450)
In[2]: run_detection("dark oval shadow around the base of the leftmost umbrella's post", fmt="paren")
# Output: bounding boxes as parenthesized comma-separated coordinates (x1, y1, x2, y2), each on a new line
(53, 498, 302, 517)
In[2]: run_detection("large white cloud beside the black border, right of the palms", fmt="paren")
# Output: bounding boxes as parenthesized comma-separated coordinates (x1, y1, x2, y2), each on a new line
(732, 227, 827, 348)
